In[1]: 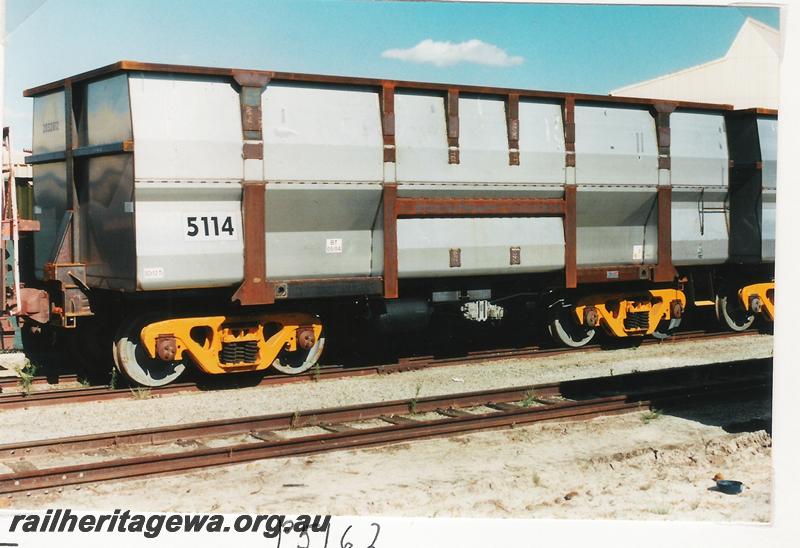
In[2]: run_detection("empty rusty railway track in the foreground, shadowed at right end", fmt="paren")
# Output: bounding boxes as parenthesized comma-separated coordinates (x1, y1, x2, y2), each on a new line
(0, 359, 772, 494)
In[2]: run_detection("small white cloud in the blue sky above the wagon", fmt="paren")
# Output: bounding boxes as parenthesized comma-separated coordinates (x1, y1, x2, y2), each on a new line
(381, 38, 525, 67)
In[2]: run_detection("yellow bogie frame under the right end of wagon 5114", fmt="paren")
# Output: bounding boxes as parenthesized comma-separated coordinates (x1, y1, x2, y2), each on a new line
(575, 289, 686, 337)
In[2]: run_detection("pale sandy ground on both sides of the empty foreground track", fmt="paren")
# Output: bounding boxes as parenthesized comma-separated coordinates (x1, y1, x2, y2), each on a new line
(0, 335, 772, 522)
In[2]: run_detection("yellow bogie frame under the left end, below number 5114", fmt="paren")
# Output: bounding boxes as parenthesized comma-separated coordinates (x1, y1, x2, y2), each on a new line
(140, 313, 322, 374)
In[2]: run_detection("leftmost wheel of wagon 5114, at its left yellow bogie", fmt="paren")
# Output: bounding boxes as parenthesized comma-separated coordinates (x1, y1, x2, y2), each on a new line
(113, 315, 188, 386)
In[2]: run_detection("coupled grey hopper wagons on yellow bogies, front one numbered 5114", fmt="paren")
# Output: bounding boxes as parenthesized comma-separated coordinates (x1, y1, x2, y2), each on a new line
(21, 61, 777, 384)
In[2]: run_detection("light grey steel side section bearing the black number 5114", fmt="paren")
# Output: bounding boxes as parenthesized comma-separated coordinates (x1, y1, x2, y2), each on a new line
(130, 72, 243, 290)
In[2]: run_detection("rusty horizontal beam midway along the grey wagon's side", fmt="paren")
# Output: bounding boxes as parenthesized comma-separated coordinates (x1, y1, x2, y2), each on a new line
(396, 198, 564, 217)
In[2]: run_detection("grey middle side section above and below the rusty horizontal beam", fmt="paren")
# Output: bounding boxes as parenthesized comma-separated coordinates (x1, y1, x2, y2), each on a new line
(392, 90, 565, 278)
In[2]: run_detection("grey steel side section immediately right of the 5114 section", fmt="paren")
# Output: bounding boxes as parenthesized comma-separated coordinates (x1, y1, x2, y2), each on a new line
(261, 81, 383, 279)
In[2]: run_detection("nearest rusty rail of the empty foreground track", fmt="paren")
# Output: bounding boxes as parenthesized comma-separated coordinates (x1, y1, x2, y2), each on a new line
(0, 372, 770, 494)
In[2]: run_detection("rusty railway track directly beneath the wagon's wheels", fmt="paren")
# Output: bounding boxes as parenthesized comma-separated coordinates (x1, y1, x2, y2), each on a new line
(0, 330, 755, 409)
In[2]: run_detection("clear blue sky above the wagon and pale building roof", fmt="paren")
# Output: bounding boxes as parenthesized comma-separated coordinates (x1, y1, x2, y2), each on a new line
(5, 0, 779, 147)
